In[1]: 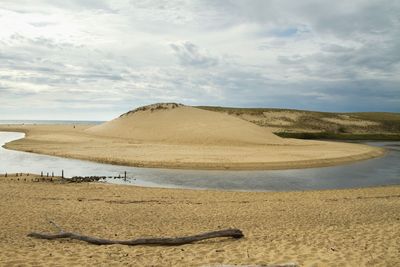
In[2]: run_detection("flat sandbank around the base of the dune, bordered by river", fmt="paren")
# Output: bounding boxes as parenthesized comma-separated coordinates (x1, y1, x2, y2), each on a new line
(0, 125, 384, 169)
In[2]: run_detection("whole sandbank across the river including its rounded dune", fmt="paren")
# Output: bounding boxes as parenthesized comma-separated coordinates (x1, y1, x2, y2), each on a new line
(0, 104, 384, 170)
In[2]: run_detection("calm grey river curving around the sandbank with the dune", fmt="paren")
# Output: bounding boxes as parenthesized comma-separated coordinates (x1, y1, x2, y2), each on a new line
(0, 132, 400, 191)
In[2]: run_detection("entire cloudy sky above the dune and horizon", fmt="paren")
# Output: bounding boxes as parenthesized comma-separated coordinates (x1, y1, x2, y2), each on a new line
(0, 0, 400, 120)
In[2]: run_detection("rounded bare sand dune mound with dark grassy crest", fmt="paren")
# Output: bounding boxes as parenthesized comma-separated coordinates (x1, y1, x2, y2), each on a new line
(86, 103, 287, 146)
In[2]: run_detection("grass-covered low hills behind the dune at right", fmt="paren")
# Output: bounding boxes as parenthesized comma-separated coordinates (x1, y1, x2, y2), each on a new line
(198, 106, 400, 140)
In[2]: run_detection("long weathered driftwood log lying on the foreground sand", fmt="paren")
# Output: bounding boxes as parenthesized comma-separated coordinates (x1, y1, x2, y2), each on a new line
(28, 221, 244, 246)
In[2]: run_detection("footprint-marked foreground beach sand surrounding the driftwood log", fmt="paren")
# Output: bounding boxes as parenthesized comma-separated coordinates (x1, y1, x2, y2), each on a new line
(0, 175, 400, 266)
